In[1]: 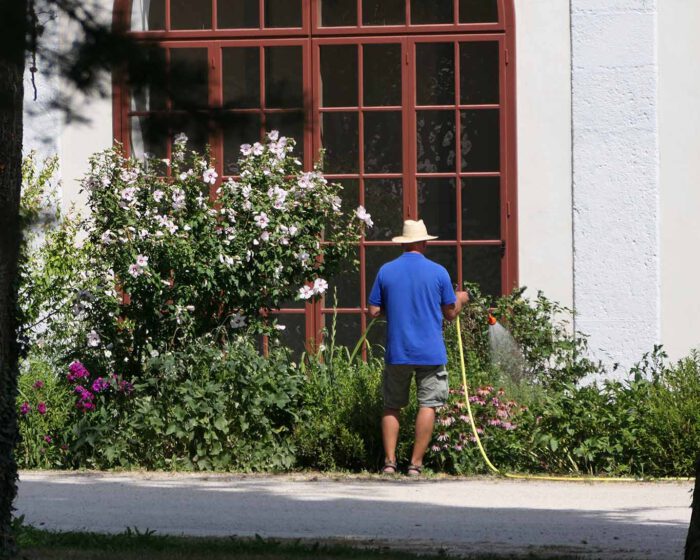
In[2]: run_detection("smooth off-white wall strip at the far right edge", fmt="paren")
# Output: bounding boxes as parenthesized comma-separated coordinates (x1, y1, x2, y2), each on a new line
(658, 0, 700, 359)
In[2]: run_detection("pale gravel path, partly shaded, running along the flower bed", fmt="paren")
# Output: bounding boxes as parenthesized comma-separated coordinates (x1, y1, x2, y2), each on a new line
(16, 471, 692, 560)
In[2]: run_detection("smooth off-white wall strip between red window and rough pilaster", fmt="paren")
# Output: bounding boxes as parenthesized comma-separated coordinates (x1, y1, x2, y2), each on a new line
(515, 0, 573, 307)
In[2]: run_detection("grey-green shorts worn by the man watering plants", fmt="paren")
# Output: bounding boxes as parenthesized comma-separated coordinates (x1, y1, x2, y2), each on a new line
(382, 364, 449, 409)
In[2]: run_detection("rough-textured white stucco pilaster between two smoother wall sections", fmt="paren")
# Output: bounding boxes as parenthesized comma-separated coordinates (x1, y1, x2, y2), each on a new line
(571, 0, 666, 370)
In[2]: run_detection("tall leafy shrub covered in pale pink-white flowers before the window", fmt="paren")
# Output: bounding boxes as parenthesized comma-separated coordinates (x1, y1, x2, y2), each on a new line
(80, 131, 371, 371)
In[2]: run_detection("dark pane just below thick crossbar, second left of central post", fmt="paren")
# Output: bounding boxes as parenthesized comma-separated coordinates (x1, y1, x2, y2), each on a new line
(221, 47, 260, 109)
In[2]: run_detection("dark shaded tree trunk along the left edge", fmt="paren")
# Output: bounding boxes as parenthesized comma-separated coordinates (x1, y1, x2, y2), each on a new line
(0, 0, 27, 557)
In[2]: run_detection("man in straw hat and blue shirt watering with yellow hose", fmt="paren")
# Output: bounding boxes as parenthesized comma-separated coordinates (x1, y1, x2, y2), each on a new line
(368, 220, 469, 476)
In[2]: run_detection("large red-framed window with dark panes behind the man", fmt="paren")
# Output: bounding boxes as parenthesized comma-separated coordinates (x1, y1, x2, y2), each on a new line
(110, 0, 517, 356)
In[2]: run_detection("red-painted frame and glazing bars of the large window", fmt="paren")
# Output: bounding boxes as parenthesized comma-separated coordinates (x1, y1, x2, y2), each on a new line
(113, 0, 518, 354)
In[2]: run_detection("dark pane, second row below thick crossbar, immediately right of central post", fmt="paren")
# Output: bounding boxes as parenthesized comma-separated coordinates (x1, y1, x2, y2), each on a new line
(321, 113, 360, 173)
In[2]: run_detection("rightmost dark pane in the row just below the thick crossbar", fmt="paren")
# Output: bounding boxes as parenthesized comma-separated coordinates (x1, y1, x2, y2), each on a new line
(459, 41, 499, 105)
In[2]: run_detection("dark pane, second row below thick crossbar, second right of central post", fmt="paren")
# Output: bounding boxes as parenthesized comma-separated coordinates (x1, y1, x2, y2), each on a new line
(364, 111, 402, 173)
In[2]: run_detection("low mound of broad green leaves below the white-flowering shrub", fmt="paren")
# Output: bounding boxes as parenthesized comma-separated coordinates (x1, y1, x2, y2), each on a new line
(67, 337, 303, 470)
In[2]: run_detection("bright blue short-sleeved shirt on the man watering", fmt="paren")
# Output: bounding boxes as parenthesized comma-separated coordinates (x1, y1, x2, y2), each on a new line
(369, 253, 457, 365)
